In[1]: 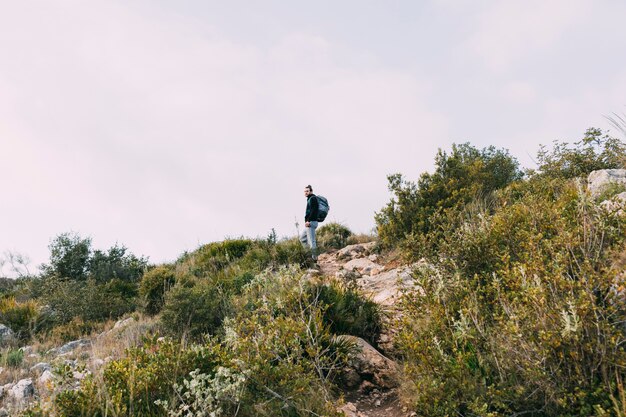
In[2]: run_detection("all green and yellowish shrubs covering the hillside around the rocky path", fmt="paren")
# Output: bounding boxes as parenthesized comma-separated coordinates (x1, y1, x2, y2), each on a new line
(0, 129, 626, 417)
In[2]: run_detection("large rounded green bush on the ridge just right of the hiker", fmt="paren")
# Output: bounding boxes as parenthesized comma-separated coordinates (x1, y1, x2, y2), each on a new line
(376, 143, 522, 252)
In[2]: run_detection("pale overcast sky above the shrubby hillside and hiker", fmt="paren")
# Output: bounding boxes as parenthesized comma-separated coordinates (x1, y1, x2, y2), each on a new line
(0, 0, 626, 275)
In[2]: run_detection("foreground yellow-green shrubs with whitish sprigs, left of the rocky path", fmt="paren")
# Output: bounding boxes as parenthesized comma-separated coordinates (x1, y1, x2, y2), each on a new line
(55, 268, 360, 416)
